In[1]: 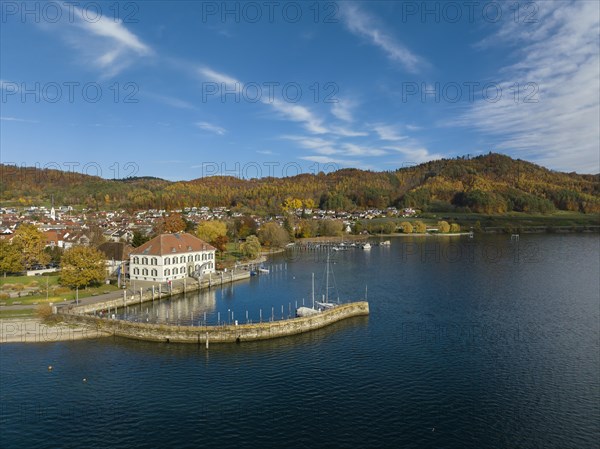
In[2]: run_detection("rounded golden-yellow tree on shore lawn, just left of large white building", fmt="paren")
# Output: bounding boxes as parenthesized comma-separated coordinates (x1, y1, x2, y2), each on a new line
(60, 246, 106, 288)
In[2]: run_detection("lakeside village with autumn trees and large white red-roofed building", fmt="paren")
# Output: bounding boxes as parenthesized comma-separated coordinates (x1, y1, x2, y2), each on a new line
(0, 206, 417, 281)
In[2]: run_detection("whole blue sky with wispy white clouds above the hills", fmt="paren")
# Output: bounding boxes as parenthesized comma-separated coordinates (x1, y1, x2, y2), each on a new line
(0, 0, 600, 180)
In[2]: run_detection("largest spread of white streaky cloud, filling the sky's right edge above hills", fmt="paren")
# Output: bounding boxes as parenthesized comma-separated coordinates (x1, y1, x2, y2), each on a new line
(458, 2, 600, 173)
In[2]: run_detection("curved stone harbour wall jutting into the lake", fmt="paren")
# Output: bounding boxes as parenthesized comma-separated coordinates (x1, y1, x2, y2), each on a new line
(61, 301, 369, 344)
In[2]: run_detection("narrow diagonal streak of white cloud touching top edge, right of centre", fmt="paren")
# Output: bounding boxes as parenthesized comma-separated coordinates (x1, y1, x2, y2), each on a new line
(338, 2, 427, 73)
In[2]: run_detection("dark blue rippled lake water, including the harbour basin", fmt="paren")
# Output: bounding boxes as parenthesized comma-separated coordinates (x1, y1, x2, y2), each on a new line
(0, 235, 600, 449)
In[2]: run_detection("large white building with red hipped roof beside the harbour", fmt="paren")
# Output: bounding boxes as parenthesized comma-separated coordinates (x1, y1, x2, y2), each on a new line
(129, 233, 216, 282)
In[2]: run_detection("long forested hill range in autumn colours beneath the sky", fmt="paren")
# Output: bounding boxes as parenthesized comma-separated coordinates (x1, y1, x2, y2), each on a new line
(0, 153, 600, 214)
